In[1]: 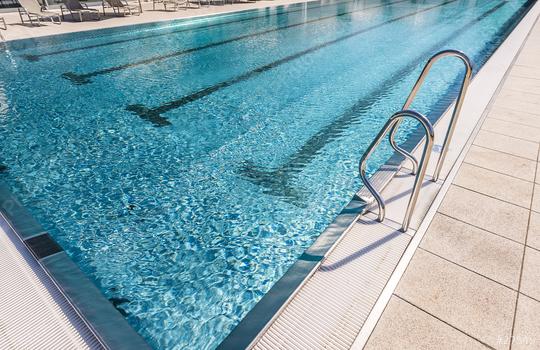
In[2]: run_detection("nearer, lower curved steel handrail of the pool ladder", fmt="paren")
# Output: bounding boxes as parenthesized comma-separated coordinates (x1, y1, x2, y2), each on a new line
(359, 110, 435, 232)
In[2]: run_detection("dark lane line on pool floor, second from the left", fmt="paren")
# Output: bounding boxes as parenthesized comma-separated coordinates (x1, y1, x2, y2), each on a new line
(62, 0, 409, 85)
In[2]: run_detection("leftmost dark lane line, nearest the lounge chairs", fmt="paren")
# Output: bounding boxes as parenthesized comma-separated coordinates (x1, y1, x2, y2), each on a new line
(21, 0, 356, 62)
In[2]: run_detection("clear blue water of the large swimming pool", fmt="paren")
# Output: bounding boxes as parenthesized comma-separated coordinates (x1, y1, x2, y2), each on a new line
(0, 0, 533, 349)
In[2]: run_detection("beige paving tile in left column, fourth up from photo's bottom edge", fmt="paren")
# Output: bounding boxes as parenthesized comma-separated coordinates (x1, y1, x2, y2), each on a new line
(439, 185, 529, 243)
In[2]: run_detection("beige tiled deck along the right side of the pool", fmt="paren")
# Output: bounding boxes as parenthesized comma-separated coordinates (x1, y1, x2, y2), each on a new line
(366, 18, 540, 349)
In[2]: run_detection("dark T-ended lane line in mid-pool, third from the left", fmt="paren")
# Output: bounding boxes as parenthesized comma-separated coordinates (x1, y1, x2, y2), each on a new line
(126, 0, 458, 127)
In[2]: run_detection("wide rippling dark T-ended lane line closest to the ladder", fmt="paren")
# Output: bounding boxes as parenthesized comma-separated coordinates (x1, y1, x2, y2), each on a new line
(239, 0, 508, 204)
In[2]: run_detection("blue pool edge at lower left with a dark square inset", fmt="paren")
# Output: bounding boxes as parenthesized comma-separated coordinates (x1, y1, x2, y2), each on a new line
(0, 182, 151, 350)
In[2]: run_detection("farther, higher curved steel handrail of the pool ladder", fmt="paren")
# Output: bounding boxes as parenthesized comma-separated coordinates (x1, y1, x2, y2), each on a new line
(390, 50, 472, 182)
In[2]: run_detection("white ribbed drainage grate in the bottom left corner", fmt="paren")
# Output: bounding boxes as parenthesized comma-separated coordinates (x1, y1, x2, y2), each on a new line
(0, 228, 103, 350)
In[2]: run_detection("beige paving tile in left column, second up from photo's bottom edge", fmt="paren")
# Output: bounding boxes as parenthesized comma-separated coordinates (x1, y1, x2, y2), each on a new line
(396, 250, 517, 349)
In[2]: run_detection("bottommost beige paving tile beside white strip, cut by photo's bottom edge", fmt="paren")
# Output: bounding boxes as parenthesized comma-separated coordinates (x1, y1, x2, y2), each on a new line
(364, 296, 488, 350)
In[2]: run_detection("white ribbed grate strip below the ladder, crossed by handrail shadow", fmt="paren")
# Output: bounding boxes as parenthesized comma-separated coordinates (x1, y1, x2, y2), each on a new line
(253, 217, 412, 350)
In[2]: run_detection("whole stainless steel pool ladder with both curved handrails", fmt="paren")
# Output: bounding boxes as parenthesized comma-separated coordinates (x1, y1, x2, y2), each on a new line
(359, 50, 472, 232)
